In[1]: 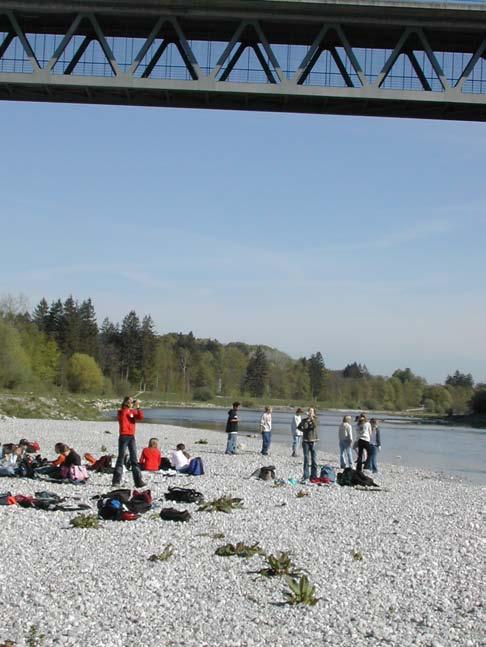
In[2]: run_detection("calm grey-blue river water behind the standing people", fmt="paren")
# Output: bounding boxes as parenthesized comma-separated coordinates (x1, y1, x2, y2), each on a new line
(141, 407, 486, 485)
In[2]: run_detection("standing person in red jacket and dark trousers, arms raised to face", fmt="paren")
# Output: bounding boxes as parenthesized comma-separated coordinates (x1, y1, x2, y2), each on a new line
(112, 395, 147, 487)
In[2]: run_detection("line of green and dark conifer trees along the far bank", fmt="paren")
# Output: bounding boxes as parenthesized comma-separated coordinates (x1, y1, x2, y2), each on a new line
(0, 295, 486, 414)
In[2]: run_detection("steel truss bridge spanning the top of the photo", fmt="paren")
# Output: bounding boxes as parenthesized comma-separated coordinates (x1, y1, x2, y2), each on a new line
(0, 0, 486, 121)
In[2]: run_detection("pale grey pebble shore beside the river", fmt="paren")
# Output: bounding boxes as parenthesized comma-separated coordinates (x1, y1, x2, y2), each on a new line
(0, 420, 486, 647)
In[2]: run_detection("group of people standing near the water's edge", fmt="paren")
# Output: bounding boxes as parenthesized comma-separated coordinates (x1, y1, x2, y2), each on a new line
(225, 402, 381, 481)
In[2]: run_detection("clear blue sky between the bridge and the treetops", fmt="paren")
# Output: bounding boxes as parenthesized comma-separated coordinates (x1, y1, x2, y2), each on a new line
(0, 102, 486, 381)
